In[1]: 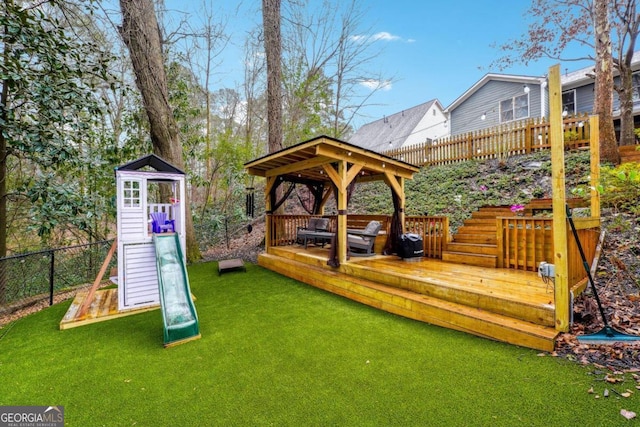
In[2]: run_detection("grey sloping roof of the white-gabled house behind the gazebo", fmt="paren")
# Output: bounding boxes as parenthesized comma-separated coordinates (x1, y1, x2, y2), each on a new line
(349, 99, 442, 151)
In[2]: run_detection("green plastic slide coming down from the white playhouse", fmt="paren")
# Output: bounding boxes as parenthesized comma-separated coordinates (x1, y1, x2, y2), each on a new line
(153, 233, 200, 347)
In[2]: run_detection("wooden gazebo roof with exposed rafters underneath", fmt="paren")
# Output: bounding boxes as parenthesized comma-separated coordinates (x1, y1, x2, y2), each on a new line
(244, 135, 420, 183)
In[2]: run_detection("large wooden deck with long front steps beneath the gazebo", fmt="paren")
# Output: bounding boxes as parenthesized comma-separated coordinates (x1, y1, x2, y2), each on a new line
(258, 245, 557, 351)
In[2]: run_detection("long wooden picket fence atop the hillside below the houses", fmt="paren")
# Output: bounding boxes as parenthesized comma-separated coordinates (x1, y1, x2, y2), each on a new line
(383, 115, 590, 166)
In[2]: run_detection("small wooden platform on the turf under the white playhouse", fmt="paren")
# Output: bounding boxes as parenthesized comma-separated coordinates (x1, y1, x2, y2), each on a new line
(60, 288, 160, 329)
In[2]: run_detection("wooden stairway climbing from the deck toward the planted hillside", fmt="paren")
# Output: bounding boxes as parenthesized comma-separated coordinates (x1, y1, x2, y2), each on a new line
(442, 206, 514, 268)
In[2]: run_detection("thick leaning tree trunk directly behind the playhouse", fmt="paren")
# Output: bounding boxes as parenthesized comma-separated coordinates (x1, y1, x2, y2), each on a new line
(120, 0, 202, 262)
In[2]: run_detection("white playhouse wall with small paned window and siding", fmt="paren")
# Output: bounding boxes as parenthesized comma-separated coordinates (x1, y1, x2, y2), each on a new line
(116, 171, 186, 310)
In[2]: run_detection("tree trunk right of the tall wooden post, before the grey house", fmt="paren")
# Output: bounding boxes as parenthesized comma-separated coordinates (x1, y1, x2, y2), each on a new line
(593, 0, 620, 164)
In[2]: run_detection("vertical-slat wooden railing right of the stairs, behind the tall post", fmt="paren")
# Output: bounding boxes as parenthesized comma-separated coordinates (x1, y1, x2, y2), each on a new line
(496, 216, 600, 285)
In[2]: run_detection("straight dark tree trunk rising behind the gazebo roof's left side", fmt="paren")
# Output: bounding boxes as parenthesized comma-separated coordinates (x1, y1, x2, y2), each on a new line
(262, 0, 282, 153)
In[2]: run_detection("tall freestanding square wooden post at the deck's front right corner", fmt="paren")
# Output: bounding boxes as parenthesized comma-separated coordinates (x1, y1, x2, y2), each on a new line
(549, 65, 570, 332)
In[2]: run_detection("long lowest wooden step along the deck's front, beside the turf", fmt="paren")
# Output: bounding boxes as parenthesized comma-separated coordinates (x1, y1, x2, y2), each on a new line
(258, 254, 557, 351)
